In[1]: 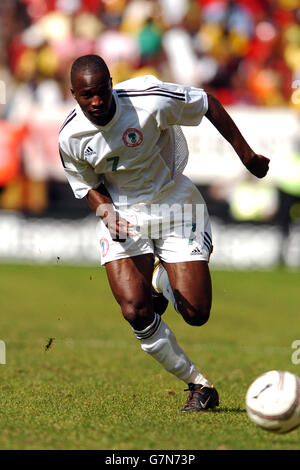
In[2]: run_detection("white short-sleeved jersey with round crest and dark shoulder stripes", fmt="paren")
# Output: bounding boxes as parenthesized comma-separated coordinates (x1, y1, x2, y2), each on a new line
(59, 76, 208, 206)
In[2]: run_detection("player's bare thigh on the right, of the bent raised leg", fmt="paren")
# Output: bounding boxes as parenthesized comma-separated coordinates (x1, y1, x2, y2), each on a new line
(163, 260, 212, 325)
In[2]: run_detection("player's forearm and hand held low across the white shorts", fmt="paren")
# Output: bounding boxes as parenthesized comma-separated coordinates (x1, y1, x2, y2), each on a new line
(87, 184, 131, 241)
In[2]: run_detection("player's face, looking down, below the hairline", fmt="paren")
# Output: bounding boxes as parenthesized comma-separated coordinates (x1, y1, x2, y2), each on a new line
(71, 72, 116, 126)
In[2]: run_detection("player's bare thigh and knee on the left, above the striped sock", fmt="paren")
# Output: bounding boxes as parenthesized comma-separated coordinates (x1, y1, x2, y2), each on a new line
(105, 253, 154, 329)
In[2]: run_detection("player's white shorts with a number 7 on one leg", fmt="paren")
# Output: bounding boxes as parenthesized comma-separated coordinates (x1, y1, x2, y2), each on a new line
(97, 176, 213, 265)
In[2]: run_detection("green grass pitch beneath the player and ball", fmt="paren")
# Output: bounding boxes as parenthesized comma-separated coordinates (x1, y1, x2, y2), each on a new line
(0, 264, 300, 450)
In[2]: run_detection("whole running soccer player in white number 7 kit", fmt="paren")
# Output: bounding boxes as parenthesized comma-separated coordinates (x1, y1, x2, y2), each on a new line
(59, 55, 269, 411)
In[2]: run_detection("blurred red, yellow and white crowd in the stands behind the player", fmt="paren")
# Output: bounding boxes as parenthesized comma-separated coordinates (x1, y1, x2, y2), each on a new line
(0, 0, 300, 235)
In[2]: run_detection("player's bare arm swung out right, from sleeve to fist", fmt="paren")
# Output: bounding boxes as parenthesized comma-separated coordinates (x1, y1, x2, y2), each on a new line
(205, 94, 270, 178)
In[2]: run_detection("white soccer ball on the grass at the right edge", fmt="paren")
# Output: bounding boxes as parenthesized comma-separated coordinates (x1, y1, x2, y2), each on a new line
(246, 370, 300, 433)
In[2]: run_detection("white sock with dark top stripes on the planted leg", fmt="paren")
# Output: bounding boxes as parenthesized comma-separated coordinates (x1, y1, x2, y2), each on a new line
(133, 313, 210, 386)
